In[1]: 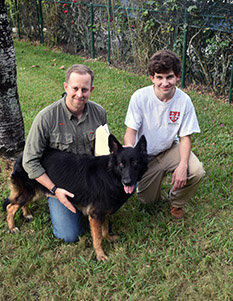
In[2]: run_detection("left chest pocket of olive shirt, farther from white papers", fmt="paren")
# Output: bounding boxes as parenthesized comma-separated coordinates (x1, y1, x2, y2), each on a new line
(49, 133, 74, 152)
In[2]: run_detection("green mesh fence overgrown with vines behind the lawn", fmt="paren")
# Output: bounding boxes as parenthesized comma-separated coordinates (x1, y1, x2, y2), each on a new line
(5, 0, 233, 103)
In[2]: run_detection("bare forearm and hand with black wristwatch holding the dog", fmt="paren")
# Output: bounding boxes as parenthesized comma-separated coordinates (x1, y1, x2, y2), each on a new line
(35, 173, 76, 213)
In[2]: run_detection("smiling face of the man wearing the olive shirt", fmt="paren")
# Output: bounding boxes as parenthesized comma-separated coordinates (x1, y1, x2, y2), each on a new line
(64, 72, 94, 112)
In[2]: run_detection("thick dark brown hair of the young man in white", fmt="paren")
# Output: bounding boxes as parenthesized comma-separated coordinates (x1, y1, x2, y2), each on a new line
(148, 50, 181, 76)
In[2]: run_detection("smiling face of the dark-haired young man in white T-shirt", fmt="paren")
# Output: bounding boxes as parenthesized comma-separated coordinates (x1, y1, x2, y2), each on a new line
(150, 71, 180, 101)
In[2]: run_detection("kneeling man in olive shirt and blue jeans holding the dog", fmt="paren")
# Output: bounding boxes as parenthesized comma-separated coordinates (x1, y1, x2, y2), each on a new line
(23, 64, 107, 242)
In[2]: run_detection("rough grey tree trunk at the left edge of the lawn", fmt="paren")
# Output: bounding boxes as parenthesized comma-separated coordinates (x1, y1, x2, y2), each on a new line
(0, 0, 24, 157)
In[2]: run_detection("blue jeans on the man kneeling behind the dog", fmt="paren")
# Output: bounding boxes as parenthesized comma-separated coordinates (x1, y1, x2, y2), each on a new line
(48, 197, 84, 243)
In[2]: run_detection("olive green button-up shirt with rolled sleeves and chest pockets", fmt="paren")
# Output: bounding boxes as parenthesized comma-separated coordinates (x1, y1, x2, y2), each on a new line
(23, 98, 107, 179)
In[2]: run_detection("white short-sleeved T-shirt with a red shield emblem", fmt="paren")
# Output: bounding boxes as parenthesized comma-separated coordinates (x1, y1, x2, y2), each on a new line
(125, 85, 200, 155)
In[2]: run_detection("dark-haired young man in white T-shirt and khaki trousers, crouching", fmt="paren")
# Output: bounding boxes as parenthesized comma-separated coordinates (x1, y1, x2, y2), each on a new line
(124, 50, 205, 218)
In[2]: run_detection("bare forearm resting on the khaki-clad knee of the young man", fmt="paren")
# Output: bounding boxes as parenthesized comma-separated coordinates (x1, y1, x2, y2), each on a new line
(171, 136, 191, 191)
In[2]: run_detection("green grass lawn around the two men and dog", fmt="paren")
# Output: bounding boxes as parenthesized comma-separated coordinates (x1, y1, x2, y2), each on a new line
(0, 41, 233, 301)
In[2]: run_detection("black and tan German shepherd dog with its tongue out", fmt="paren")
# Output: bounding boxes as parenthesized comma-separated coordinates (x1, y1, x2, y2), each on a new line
(3, 135, 148, 261)
